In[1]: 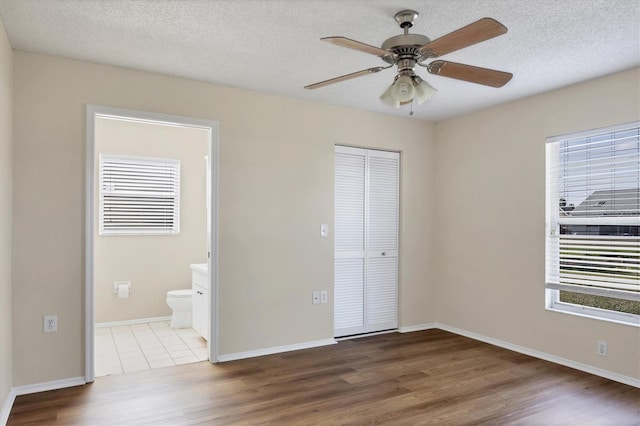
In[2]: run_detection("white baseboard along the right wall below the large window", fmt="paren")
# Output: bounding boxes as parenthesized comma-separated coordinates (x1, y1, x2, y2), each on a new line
(436, 324, 640, 388)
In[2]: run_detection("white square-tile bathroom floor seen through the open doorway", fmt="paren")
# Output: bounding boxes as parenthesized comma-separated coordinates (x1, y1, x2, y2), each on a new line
(95, 321, 209, 377)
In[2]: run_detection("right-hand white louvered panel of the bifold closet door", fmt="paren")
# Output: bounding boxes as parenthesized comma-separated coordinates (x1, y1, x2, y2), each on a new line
(365, 150, 400, 332)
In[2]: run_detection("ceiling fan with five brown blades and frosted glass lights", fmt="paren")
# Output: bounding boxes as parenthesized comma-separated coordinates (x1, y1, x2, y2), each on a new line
(305, 10, 513, 108)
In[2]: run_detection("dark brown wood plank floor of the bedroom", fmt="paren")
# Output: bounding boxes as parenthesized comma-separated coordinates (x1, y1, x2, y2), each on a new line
(8, 330, 640, 425)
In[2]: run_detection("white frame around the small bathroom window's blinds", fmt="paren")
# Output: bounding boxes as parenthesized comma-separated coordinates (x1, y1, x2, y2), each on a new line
(98, 153, 180, 236)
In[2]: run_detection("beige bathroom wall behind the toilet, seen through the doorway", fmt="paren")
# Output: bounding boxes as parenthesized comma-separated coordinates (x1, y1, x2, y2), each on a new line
(94, 117, 209, 323)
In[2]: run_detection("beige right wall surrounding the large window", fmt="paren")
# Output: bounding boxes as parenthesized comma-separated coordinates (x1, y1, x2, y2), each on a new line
(434, 69, 640, 378)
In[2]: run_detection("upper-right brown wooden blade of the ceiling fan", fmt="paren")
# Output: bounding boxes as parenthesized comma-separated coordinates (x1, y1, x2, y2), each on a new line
(420, 18, 507, 58)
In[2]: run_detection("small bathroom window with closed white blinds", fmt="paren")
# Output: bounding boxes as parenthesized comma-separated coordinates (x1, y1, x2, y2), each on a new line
(99, 154, 180, 235)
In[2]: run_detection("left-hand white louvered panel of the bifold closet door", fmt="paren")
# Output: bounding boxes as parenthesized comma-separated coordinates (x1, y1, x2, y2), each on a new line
(333, 146, 366, 336)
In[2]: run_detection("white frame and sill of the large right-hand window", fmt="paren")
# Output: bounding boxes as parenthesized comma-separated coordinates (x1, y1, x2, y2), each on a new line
(545, 121, 640, 327)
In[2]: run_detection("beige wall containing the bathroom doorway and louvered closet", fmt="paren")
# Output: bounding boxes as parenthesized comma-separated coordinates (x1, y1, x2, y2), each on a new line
(13, 52, 436, 385)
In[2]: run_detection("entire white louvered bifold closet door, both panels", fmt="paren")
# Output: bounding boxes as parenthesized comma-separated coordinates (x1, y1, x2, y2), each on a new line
(334, 146, 400, 337)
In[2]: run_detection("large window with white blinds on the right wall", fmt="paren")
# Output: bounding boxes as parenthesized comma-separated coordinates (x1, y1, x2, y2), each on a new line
(546, 122, 640, 325)
